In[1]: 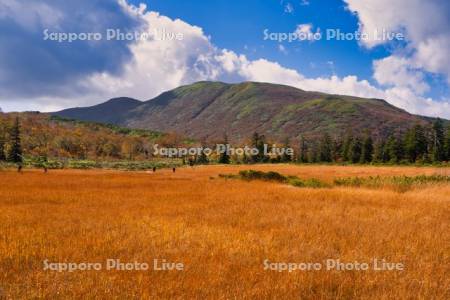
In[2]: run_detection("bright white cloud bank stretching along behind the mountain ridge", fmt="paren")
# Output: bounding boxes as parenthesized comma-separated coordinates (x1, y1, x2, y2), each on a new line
(83, 2, 450, 117)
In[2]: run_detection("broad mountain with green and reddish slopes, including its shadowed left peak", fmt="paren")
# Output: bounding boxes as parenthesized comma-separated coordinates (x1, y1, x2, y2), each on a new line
(54, 81, 442, 141)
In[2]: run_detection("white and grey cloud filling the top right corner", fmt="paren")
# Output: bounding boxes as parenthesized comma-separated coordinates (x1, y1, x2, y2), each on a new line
(344, 0, 450, 83)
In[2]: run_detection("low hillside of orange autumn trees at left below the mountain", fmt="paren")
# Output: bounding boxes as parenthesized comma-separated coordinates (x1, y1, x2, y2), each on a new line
(0, 112, 183, 161)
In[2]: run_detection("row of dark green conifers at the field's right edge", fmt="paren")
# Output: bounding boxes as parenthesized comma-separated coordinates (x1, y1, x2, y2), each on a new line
(232, 119, 450, 164)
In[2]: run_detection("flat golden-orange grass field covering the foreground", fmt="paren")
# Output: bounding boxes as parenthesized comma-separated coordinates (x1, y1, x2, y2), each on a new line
(0, 165, 450, 299)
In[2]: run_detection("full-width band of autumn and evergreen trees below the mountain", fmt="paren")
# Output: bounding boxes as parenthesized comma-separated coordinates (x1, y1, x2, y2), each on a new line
(0, 115, 450, 165)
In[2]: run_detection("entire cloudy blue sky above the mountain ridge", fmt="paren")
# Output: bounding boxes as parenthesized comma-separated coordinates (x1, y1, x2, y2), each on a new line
(0, 0, 450, 118)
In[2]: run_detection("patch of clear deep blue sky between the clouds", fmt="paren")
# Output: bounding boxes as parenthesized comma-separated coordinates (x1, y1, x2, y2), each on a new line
(133, 0, 382, 78)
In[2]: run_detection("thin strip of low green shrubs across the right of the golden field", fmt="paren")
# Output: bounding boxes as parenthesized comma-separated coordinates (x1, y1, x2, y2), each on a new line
(219, 170, 450, 192)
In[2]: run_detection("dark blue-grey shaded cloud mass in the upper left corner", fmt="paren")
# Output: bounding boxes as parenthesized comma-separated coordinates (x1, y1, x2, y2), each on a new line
(0, 0, 140, 99)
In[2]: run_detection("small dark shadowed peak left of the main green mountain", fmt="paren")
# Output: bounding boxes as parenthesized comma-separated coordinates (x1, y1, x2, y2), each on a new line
(54, 97, 142, 125)
